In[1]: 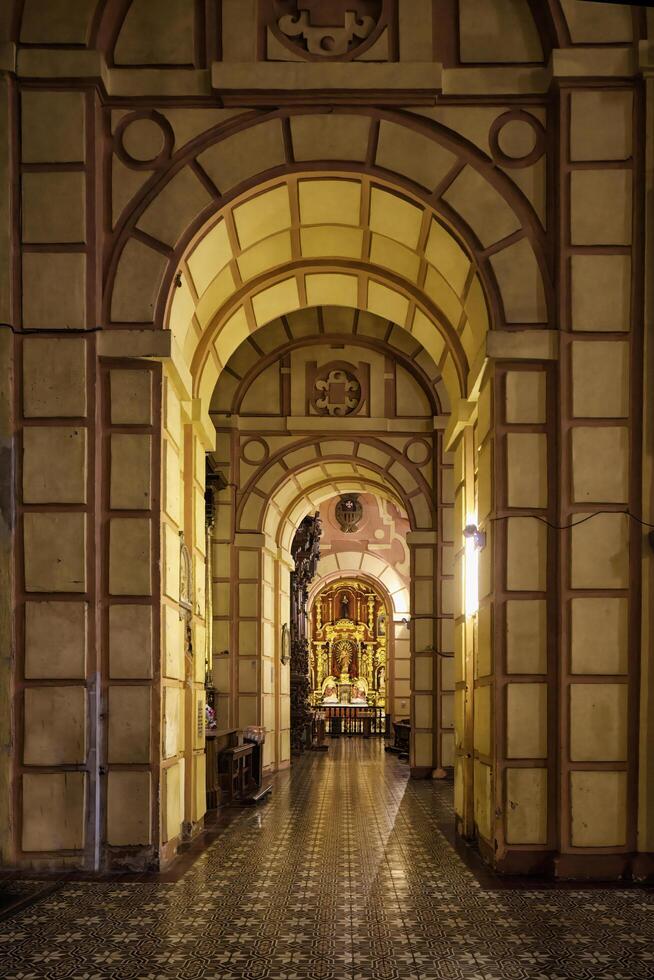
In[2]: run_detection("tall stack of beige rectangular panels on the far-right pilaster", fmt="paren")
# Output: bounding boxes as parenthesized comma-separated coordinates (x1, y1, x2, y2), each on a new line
(561, 80, 640, 849)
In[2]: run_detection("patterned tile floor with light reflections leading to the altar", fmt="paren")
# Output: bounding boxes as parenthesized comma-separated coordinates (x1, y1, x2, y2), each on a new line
(0, 740, 654, 980)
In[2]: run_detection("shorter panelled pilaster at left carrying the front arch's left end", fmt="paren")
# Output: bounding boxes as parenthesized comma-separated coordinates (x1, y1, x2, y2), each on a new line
(105, 360, 162, 868)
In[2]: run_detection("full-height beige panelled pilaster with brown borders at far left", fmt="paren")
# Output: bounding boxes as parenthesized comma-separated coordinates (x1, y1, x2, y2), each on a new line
(11, 82, 98, 868)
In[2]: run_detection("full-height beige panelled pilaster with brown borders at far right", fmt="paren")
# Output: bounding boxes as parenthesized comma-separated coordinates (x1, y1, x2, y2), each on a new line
(556, 69, 646, 877)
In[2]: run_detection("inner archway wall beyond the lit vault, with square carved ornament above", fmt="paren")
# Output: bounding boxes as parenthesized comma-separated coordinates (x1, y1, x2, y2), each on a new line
(206, 306, 446, 774)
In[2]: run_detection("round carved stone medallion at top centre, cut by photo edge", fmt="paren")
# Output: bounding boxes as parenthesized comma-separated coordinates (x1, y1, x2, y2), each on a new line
(275, 0, 383, 58)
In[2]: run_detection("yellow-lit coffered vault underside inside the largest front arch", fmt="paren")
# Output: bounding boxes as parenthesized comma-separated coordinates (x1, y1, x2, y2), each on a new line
(168, 173, 512, 403)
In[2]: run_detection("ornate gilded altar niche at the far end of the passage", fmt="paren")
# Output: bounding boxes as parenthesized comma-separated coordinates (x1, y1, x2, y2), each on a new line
(309, 579, 388, 709)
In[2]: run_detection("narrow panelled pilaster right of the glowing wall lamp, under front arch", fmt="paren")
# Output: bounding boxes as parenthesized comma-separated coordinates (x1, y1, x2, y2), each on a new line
(490, 347, 558, 873)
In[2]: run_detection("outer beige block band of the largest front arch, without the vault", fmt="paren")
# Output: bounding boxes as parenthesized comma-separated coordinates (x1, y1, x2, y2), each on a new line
(105, 109, 553, 358)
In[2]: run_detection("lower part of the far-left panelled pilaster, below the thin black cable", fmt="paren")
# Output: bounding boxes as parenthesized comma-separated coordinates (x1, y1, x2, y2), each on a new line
(16, 335, 93, 866)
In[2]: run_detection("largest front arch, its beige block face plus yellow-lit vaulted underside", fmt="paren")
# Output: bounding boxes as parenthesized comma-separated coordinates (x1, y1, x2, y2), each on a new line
(106, 109, 552, 400)
